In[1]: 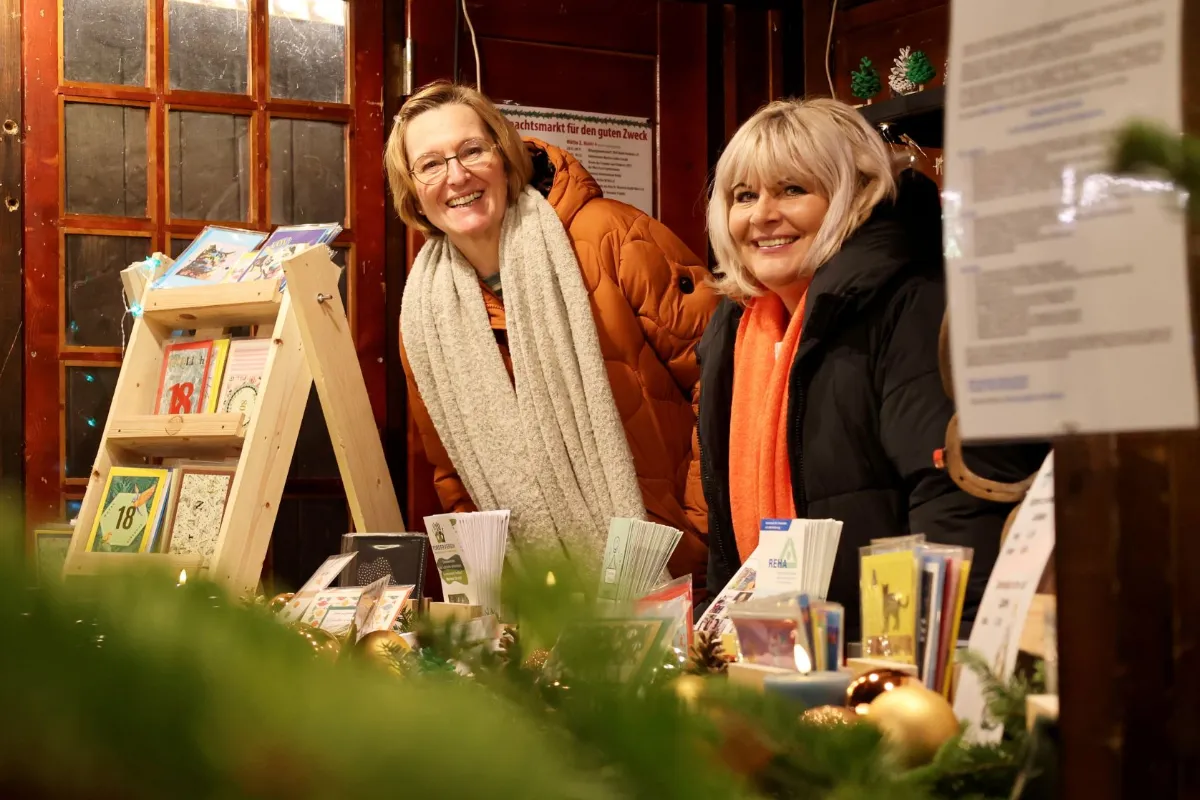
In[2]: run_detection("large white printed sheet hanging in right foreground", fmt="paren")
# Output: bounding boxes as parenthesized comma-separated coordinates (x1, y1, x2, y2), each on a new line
(943, 0, 1198, 440)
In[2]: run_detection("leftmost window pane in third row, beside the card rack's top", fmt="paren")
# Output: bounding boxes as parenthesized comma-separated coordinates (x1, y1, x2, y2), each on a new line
(64, 234, 150, 347)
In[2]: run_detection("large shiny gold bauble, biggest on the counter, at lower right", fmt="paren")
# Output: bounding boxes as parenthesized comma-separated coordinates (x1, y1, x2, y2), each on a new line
(865, 684, 959, 766)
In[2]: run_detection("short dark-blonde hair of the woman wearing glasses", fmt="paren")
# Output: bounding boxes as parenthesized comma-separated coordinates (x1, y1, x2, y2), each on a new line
(384, 80, 533, 236)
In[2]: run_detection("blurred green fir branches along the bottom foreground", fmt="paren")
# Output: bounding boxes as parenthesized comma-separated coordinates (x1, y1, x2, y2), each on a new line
(0, 542, 1051, 800)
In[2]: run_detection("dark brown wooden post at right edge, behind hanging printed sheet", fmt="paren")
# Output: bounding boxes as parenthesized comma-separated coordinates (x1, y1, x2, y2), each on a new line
(1055, 4, 1200, 800)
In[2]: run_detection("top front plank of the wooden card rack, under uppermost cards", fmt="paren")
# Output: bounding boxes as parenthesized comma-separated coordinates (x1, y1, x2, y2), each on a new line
(142, 278, 283, 331)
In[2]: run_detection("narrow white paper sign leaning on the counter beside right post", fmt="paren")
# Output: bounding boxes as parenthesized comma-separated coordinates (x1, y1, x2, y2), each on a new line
(954, 452, 1055, 741)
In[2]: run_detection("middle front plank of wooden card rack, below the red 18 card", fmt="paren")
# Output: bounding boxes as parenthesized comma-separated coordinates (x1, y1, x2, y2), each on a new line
(108, 411, 246, 458)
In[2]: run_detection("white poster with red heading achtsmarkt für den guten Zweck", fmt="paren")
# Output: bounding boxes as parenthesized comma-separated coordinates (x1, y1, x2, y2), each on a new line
(499, 106, 654, 216)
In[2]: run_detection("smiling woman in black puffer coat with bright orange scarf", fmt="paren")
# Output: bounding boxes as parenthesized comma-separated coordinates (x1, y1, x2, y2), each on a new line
(692, 100, 1041, 634)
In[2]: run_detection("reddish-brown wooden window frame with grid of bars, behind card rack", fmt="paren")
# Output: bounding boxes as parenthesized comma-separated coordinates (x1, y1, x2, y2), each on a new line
(22, 0, 388, 545)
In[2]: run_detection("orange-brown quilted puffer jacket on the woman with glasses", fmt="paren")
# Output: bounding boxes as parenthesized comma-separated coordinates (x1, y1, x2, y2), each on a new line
(400, 139, 716, 589)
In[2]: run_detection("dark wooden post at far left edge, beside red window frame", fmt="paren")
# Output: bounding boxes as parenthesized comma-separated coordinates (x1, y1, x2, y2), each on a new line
(0, 0, 25, 552)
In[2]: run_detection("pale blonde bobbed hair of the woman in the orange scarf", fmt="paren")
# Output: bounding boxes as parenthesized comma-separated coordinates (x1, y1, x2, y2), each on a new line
(708, 97, 896, 302)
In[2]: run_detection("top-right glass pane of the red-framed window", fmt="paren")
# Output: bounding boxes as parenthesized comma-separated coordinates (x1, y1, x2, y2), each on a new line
(270, 0, 349, 103)
